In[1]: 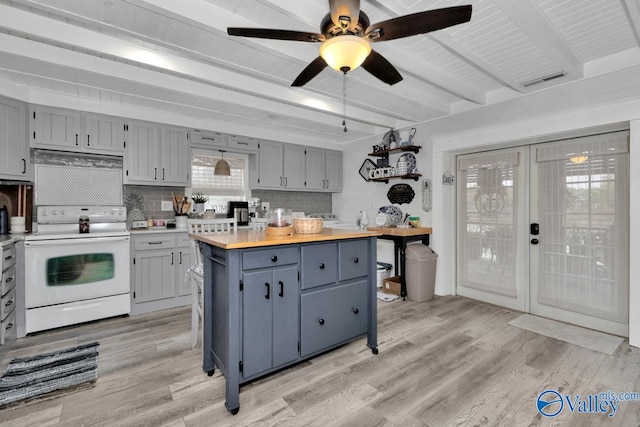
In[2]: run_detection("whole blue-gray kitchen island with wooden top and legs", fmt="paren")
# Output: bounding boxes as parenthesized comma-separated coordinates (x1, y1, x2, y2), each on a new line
(191, 229, 380, 415)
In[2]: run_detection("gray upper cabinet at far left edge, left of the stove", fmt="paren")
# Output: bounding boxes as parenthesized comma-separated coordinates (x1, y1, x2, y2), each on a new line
(0, 98, 33, 180)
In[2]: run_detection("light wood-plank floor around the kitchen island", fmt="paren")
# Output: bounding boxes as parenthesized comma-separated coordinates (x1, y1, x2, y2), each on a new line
(0, 297, 640, 427)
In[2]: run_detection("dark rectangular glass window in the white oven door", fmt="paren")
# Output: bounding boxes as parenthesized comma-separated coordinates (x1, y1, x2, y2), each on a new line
(47, 253, 115, 286)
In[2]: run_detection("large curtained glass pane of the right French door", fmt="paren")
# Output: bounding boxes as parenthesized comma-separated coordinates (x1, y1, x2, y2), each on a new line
(538, 153, 629, 323)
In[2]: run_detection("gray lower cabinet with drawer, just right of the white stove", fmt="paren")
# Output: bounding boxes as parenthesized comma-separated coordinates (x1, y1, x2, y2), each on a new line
(131, 233, 191, 314)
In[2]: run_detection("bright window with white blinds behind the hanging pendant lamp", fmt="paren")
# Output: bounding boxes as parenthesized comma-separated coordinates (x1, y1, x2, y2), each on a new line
(191, 150, 248, 213)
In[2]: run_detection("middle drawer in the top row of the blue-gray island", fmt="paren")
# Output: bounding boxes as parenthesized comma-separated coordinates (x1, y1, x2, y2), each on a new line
(301, 243, 338, 289)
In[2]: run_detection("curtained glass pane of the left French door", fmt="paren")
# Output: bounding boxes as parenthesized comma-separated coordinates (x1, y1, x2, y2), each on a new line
(457, 159, 518, 298)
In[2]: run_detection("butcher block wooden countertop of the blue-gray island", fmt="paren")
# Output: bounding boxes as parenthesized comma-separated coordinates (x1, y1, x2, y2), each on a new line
(190, 228, 382, 249)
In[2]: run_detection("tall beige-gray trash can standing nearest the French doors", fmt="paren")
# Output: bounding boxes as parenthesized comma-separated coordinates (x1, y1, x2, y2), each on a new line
(405, 244, 438, 302)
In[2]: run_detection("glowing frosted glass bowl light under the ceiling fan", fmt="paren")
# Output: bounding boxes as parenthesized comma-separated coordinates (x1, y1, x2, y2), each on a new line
(320, 34, 371, 72)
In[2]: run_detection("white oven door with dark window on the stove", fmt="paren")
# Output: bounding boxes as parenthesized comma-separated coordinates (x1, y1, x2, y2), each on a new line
(25, 236, 130, 308)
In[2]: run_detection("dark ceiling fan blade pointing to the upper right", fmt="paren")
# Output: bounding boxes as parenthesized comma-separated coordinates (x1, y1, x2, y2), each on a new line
(365, 5, 472, 42)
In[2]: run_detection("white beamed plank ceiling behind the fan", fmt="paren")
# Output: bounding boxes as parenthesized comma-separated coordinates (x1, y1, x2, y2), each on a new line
(0, 0, 640, 146)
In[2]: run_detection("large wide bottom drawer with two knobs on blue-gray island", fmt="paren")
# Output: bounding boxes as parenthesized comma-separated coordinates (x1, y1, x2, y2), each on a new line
(300, 280, 368, 357)
